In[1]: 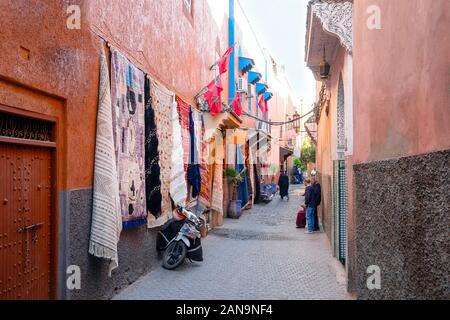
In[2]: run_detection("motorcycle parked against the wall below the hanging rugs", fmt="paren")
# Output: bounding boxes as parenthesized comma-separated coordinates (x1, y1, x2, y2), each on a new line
(156, 206, 206, 270)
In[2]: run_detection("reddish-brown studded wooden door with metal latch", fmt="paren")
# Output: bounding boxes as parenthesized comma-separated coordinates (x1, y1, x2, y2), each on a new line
(0, 143, 53, 300)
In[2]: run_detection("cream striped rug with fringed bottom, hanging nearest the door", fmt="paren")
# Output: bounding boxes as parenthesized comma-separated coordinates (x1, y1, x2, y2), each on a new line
(89, 52, 122, 276)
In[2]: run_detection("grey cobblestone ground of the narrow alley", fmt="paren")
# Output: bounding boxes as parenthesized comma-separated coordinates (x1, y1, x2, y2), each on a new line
(114, 187, 350, 300)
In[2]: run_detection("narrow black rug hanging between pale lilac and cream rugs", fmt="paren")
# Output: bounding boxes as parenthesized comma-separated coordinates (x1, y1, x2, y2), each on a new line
(145, 78, 162, 220)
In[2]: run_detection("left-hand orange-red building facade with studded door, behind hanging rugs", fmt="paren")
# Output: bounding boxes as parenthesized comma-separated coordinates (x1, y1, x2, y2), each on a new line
(0, 0, 286, 299)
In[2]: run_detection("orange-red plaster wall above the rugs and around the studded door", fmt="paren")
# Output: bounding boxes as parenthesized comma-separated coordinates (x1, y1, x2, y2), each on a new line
(0, 0, 232, 189)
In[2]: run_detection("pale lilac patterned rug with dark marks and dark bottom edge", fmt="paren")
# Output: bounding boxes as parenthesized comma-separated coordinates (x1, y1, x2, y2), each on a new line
(111, 49, 147, 229)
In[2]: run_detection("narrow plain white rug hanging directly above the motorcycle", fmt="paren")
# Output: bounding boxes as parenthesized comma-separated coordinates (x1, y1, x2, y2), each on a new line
(170, 96, 187, 206)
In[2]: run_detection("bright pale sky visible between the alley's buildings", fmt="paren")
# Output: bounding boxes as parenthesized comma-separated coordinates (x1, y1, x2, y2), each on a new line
(236, 0, 316, 109)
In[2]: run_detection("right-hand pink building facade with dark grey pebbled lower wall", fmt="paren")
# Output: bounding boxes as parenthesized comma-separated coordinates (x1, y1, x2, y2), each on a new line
(306, 0, 450, 299)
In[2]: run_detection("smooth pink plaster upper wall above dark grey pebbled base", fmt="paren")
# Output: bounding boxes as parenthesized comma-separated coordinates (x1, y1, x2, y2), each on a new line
(353, 0, 450, 163)
